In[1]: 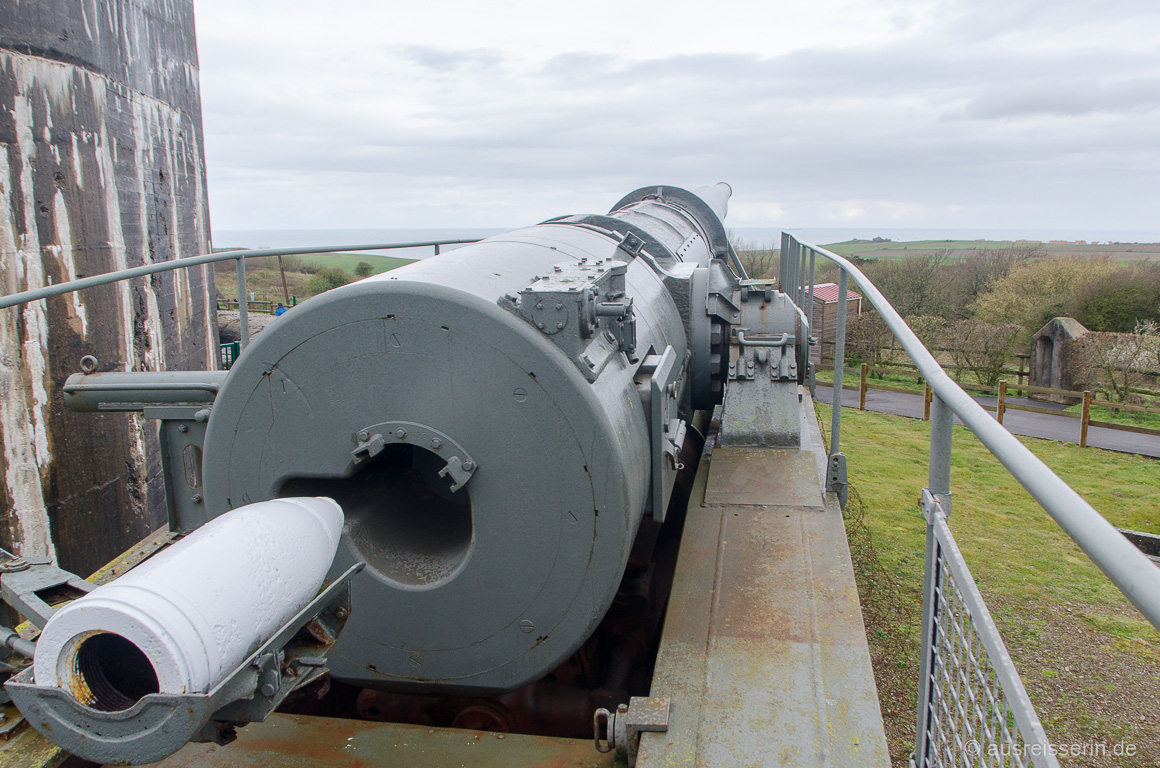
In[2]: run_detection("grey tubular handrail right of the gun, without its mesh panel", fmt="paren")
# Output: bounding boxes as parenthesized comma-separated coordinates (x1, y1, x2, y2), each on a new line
(781, 238, 1160, 630)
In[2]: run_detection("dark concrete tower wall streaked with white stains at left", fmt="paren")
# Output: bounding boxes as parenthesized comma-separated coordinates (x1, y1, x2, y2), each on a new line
(0, 0, 217, 574)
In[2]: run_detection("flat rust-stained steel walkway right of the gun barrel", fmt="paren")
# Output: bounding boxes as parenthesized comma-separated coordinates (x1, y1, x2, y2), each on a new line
(638, 394, 890, 768)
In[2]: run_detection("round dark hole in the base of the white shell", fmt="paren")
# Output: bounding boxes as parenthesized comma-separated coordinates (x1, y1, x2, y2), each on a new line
(64, 632, 160, 712)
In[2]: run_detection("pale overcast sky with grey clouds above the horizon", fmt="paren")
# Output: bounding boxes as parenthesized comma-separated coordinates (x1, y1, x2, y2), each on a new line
(195, 0, 1160, 231)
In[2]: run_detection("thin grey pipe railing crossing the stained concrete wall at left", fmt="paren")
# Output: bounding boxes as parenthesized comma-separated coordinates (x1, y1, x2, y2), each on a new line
(0, 239, 479, 348)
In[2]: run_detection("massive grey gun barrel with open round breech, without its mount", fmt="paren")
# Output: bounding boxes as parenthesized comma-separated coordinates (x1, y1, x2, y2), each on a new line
(193, 186, 732, 693)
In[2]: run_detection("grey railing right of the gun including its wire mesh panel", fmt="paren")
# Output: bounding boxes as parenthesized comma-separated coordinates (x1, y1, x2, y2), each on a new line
(778, 234, 1160, 768)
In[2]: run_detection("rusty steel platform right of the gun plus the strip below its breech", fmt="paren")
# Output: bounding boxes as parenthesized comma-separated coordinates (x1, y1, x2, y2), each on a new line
(0, 392, 890, 768)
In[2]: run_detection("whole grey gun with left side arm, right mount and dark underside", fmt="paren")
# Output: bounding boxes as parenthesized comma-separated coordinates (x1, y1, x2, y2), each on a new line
(14, 184, 825, 754)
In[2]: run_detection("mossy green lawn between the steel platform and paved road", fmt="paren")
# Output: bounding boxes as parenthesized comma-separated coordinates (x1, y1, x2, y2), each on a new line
(818, 405, 1160, 767)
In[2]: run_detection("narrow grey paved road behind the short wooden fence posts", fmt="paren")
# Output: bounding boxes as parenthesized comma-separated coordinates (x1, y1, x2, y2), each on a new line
(818, 384, 1160, 458)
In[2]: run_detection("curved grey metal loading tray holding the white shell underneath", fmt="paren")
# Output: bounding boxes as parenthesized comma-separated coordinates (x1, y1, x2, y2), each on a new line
(5, 563, 363, 765)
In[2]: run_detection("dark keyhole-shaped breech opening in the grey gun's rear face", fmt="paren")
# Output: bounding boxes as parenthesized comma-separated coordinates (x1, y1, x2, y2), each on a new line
(280, 444, 474, 589)
